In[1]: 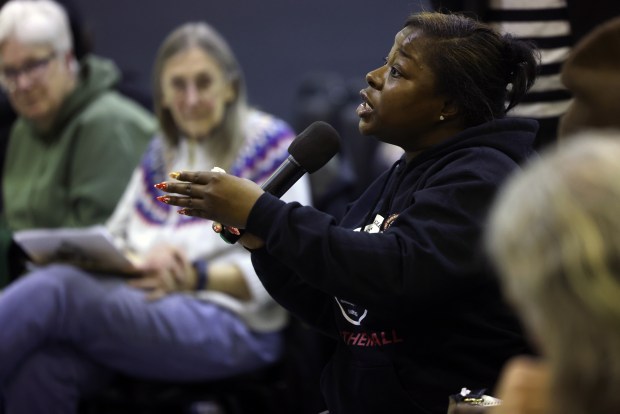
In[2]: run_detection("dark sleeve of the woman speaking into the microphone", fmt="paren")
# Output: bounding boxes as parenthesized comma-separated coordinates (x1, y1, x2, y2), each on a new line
(247, 150, 514, 308)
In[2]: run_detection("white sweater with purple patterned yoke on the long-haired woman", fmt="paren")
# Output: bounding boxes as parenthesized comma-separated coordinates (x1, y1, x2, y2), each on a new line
(108, 110, 310, 331)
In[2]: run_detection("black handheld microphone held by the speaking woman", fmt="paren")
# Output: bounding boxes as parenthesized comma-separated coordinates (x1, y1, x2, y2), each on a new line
(220, 121, 340, 244)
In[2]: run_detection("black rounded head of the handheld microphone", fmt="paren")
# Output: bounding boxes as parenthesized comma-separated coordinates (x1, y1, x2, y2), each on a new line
(288, 121, 340, 174)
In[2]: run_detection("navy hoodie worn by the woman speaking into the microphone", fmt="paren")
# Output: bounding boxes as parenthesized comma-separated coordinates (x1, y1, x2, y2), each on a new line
(247, 118, 537, 414)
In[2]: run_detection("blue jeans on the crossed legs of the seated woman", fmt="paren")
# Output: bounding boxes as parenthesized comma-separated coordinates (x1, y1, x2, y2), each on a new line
(0, 265, 283, 414)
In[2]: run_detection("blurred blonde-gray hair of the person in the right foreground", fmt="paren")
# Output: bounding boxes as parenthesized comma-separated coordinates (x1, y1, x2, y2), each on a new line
(486, 130, 620, 414)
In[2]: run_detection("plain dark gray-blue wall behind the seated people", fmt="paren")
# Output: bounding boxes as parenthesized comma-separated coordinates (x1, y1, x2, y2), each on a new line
(75, 0, 427, 126)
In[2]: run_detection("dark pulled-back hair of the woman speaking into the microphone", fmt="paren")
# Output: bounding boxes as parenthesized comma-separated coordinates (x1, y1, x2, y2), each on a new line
(405, 12, 539, 126)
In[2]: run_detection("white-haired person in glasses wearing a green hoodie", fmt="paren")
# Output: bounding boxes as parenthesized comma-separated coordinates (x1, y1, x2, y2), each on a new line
(0, 0, 156, 286)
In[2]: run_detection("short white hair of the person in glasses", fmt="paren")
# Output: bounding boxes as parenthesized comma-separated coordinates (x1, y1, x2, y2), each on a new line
(0, 0, 73, 53)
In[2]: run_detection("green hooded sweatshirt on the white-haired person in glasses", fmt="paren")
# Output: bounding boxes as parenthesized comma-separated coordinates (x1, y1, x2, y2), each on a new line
(0, 56, 156, 287)
